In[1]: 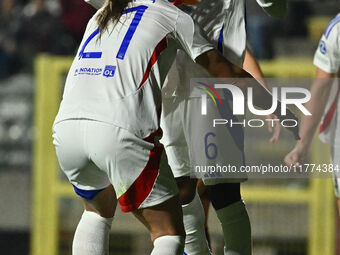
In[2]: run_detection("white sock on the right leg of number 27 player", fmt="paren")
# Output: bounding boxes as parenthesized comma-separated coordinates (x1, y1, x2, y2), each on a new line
(151, 236, 184, 255)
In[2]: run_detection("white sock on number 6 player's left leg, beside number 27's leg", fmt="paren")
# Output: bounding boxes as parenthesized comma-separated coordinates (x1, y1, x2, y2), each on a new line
(182, 192, 211, 255)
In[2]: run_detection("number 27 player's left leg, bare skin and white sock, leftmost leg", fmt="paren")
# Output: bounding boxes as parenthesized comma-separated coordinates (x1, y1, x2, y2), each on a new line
(72, 185, 117, 255)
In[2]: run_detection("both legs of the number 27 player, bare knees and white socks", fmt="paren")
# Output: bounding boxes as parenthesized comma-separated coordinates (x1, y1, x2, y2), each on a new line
(73, 185, 185, 255)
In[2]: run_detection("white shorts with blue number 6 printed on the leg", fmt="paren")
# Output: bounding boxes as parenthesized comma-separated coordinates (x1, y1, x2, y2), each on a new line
(161, 97, 247, 185)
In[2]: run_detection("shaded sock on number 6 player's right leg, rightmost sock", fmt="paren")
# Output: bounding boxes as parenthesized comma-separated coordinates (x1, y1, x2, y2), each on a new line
(216, 201, 252, 255)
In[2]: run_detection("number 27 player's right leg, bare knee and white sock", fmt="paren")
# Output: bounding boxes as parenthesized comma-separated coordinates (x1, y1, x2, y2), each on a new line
(133, 196, 185, 255)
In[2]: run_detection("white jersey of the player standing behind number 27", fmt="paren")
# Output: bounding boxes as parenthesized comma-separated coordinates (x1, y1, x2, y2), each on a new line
(163, 0, 247, 98)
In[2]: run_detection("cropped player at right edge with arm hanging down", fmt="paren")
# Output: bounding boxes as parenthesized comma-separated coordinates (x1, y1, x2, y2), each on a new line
(285, 13, 340, 214)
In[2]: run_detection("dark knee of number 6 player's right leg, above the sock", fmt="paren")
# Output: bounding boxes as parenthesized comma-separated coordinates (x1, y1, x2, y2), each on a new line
(208, 183, 241, 210)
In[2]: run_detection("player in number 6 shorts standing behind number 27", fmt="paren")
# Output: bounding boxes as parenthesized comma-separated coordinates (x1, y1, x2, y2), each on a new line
(161, 0, 285, 255)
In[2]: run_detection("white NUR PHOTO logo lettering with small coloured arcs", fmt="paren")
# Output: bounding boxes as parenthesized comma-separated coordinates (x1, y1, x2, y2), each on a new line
(196, 81, 312, 128)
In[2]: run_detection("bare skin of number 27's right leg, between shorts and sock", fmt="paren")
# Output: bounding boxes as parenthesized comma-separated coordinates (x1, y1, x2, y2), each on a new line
(133, 196, 185, 241)
